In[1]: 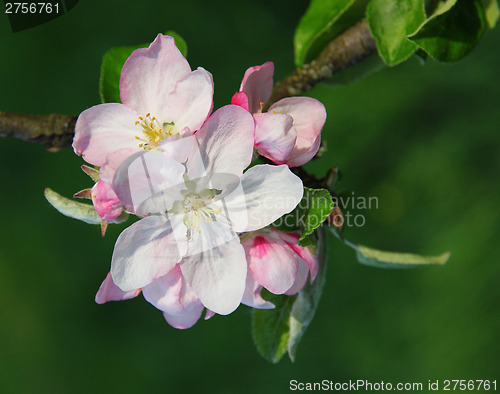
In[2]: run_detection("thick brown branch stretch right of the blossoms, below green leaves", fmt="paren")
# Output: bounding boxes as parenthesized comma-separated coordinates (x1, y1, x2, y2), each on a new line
(268, 19, 377, 106)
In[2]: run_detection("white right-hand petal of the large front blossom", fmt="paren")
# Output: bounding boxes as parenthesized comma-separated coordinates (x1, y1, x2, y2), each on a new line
(224, 164, 304, 232)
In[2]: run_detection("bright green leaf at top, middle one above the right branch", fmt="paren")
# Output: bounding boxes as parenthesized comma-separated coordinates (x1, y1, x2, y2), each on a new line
(366, 0, 426, 66)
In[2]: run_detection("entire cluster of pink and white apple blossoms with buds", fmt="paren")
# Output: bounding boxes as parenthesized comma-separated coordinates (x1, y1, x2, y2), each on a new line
(73, 34, 326, 329)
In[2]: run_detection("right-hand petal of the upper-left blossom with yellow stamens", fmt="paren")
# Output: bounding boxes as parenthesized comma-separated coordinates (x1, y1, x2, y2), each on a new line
(164, 67, 214, 131)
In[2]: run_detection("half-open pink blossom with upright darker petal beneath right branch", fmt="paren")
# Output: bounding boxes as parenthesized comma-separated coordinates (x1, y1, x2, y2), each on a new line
(231, 62, 326, 167)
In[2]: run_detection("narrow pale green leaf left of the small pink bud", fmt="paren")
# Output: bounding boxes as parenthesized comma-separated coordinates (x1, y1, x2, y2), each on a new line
(44, 187, 128, 225)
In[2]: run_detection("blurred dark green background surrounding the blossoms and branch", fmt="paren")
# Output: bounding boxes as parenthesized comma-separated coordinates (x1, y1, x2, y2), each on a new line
(0, 0, 500, 393)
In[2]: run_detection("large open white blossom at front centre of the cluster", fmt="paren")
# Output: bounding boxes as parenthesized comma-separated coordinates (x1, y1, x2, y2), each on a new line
(111, 105, 303, 315)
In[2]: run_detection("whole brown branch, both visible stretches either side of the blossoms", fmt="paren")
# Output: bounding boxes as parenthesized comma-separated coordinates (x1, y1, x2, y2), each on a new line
(0, 20, 376, 150)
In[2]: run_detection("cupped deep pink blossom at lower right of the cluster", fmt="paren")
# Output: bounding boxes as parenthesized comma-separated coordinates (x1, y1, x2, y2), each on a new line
(242, 228, 318, 309)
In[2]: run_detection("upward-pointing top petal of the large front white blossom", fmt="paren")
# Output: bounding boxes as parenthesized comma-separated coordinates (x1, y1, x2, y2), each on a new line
(188, 105, 254, 179)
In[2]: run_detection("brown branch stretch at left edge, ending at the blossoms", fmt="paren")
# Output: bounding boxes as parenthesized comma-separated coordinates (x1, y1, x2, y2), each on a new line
(0, 112, 76, 150)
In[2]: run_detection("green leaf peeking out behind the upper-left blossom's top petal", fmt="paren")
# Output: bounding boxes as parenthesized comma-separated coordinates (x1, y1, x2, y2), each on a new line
(99, 30, 187, 103)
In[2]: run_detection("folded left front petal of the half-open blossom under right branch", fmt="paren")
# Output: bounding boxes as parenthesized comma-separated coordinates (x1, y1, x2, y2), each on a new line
(253, 113, 297, 164)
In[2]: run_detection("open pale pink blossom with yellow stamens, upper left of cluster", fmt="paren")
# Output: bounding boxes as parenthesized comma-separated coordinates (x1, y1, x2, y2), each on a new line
(73, 34, 213, 184)
